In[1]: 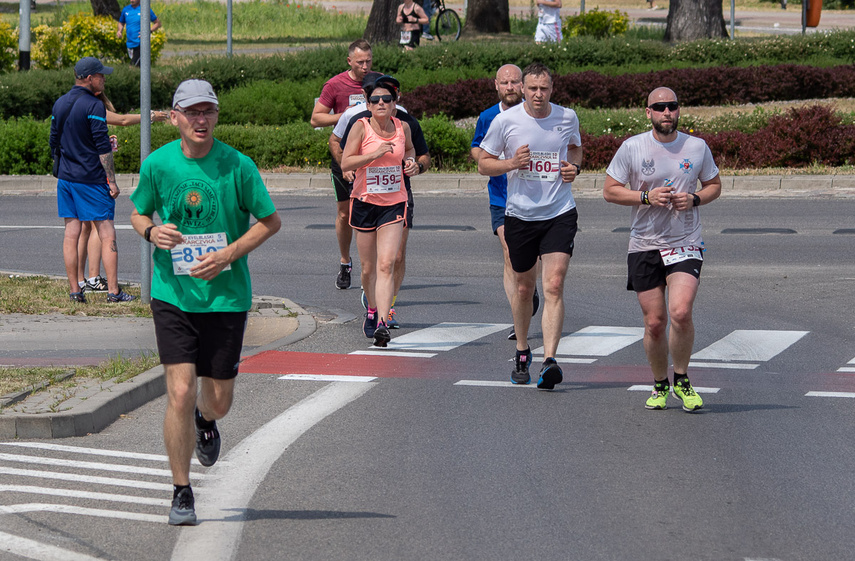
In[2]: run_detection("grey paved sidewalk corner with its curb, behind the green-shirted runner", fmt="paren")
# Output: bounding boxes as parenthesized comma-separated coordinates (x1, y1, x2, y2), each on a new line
(0, 296, 316, 439)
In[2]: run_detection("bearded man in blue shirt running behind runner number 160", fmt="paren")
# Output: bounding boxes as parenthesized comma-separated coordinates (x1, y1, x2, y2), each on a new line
(469, 64, 540, 341)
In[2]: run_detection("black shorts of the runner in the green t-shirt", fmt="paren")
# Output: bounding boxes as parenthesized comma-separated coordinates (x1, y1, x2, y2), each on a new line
(151, 298, 247, 380)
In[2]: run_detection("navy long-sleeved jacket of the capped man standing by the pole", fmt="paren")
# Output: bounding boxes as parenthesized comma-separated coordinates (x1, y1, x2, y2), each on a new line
(50, 86, 113, 185)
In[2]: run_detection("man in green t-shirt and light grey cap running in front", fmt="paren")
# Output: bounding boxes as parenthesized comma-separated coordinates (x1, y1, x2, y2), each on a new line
(131, 80, 281, 525)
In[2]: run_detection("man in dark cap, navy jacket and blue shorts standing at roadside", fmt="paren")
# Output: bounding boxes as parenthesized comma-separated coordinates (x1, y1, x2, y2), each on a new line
(50, 57, 134, 304)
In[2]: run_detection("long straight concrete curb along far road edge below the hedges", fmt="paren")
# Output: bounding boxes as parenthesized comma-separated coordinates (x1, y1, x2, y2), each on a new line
(5, 173, 855, 198)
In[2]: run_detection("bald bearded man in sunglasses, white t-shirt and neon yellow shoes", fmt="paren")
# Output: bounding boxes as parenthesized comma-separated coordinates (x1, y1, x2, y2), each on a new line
(603, 88, 721, 411)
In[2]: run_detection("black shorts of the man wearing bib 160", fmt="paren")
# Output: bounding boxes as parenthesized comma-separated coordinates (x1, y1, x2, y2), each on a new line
(505, 208, 579, 273)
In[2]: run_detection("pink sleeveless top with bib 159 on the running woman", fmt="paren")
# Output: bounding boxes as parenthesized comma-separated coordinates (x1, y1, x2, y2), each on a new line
(350, 117, 407, 206)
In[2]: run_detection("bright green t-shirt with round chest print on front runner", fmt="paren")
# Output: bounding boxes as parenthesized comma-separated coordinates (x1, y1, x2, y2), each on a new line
(131, 139, 276, 313)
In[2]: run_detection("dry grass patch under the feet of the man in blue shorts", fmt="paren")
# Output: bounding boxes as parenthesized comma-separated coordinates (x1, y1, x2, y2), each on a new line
(0, 275, 151, 317)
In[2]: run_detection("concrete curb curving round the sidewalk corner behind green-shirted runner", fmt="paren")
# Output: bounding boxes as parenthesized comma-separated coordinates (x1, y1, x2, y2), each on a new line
(0, 296, 317, 439)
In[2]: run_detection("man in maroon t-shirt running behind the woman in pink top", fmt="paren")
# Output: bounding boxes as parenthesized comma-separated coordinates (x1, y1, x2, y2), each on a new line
(310, 39, 371, 290)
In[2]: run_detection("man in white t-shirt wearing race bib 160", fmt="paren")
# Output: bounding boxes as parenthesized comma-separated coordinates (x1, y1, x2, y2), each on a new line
(478, 62, 582, 390)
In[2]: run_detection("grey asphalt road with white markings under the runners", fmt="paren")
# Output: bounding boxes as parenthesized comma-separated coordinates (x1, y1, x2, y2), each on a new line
(0, 190, 855, 561)
